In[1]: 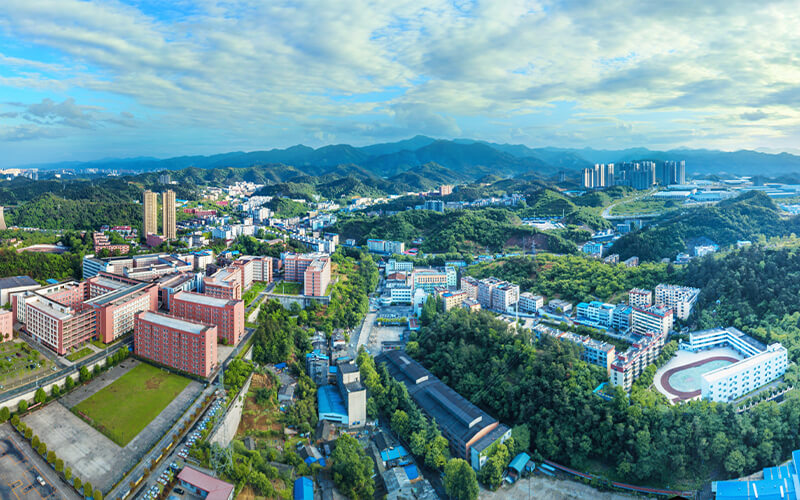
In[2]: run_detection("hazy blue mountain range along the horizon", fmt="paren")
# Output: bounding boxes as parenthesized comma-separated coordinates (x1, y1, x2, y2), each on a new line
(17, 135, 800, 180)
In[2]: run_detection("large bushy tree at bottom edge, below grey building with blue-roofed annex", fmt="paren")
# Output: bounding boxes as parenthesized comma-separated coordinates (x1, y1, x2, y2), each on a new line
(331, 434, 375, 500)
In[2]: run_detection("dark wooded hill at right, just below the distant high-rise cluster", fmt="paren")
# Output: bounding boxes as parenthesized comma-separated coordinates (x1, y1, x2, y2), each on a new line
(611, 191, 800, 260)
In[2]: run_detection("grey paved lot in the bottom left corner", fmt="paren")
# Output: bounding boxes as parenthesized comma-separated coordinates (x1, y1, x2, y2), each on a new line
(0, 424, 78, 500)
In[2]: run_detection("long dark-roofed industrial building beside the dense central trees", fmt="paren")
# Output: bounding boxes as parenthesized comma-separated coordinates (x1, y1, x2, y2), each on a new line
(375, 350, 511, 470)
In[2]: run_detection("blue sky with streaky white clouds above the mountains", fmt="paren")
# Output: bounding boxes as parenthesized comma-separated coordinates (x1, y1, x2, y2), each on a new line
(0, 0, 800, 165)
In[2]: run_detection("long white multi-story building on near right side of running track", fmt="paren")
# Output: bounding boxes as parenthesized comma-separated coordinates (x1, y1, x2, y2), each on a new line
(700, 343, 789, 402)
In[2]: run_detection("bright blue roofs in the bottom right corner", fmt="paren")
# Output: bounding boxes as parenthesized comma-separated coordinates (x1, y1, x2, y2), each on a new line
(711, 450, 800, 500)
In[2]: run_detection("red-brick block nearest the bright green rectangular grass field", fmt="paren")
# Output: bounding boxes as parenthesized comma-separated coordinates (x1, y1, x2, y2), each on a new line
(133, 311, 217, 377)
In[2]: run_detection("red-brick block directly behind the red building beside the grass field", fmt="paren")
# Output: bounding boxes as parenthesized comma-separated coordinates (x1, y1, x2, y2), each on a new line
(170, 292, 244, 345)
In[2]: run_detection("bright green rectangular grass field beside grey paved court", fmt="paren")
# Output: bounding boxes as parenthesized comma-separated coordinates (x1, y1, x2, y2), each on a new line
(73, 363, 190, 446)
